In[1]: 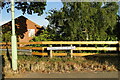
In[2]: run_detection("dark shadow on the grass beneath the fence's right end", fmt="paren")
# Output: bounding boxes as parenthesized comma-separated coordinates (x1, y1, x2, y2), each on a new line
(85, 44, 120, 71)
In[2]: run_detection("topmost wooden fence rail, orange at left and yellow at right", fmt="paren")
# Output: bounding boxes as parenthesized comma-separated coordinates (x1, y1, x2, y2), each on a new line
(0, 41, 119, 45)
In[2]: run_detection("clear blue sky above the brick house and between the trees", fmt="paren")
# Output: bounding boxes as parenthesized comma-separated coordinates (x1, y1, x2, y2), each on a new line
(0, 0, 120, 26)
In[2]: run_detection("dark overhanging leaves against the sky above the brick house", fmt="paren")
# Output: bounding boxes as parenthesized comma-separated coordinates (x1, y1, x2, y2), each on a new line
(2, 2, 46, 16)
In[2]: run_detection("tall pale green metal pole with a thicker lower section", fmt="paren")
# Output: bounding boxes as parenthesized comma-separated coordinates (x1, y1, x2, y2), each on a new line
(11, 0, 17, 70)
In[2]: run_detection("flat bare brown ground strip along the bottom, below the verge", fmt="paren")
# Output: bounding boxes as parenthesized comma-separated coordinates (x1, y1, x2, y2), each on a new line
(7, 72, 119, 78)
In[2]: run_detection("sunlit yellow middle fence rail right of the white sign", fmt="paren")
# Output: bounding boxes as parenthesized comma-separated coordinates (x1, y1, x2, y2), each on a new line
(73, 47, 117, 51)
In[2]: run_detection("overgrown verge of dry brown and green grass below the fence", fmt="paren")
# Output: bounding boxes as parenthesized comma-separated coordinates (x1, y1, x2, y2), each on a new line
(3, 56, 118, 76)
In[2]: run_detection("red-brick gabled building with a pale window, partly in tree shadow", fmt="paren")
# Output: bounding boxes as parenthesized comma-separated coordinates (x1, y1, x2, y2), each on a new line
(2, 16, 44, 42)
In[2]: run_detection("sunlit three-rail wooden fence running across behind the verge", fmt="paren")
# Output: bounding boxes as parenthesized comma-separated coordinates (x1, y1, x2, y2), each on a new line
(0, 41, 120, 57)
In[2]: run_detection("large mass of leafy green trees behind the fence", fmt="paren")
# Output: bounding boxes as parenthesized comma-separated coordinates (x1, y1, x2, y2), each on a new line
(47, 2, 118, 40)
